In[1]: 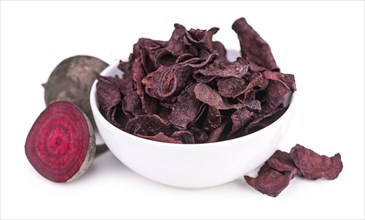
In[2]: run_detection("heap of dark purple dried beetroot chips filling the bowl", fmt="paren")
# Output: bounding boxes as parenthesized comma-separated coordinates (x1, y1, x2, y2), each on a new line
(97, 18, 296, 144)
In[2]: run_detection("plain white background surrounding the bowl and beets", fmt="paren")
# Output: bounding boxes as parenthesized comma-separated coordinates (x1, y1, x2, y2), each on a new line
(0, 1, 364, 219)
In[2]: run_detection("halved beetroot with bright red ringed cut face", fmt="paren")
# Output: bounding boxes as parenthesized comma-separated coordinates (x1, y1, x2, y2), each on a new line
(25, 101, 95, 182)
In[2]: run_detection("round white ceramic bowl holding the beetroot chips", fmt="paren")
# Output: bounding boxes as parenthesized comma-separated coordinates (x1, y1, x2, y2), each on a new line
(90, 64, 295, 189)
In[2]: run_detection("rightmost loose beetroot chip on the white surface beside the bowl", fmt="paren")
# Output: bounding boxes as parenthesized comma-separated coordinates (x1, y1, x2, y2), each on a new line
(290, 144, 343, 180)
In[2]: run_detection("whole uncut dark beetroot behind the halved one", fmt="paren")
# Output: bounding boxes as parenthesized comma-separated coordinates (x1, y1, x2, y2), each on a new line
(43, 55, 108, 128)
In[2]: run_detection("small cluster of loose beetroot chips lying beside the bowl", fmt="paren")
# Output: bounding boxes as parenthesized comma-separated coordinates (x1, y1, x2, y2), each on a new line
(244, 144, 343, 197)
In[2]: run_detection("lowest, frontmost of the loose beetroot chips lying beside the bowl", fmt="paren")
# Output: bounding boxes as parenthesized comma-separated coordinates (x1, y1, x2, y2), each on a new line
(244, 164, 291, 197)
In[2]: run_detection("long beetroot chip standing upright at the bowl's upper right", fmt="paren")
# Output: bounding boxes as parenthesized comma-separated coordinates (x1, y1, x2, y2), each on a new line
(232, 18, 279, 71)
